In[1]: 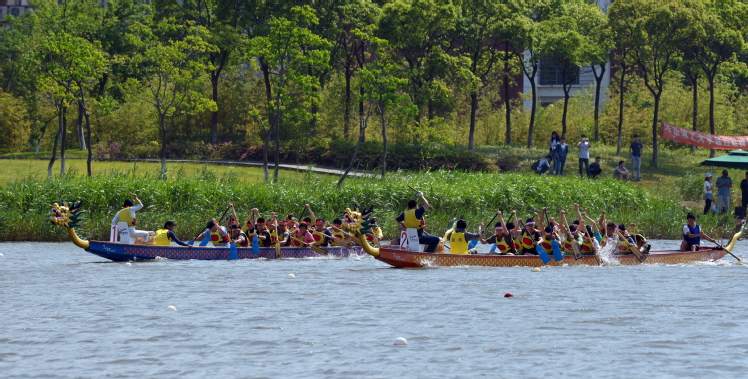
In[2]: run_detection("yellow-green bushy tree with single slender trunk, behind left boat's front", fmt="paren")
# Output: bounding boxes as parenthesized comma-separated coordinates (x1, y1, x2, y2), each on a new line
(132, 18, 218, 177)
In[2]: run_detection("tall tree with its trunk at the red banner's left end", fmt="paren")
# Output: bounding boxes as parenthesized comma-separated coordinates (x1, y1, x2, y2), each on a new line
(611, 0, 696, 167)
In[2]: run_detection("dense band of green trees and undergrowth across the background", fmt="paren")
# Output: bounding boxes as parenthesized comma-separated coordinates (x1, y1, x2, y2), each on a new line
(0, 0, 748, 176)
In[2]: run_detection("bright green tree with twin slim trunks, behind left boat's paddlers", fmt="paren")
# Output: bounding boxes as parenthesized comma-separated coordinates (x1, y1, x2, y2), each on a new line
(247, 6, 330, 181)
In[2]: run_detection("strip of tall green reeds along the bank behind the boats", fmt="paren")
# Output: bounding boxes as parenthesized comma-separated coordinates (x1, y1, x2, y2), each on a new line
(0, 164, 733, 241)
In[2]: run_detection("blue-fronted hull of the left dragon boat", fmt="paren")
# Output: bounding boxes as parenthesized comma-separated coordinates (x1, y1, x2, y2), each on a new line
(85, 241, 365, 262)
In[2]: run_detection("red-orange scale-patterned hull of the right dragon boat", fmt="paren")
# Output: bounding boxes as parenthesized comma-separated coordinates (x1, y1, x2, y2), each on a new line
(376, 249, 726, 267)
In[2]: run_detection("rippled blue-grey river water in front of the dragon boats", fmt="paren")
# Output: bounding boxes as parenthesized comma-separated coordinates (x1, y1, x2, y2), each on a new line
(0, 241, 748, 378)
